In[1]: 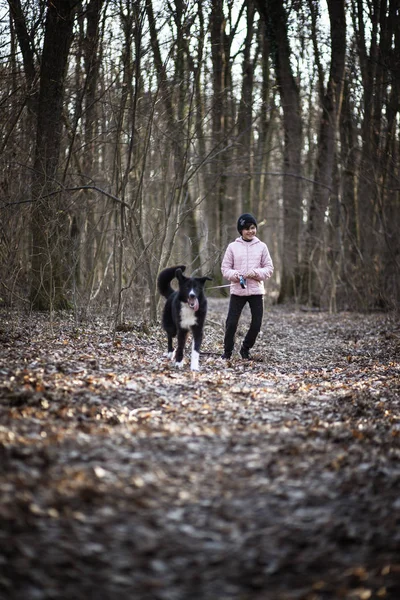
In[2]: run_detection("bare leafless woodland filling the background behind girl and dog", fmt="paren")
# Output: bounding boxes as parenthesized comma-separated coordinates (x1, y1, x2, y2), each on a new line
(0, 0, 400, 322)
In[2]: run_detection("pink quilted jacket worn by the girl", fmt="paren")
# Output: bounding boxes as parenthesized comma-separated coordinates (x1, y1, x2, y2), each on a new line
(221, 237, 274, 296)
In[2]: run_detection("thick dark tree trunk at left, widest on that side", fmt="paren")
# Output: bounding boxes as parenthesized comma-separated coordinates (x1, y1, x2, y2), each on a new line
(30, 0, 76, 310)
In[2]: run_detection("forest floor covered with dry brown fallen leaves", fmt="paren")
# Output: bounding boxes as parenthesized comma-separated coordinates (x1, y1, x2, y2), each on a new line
(0, 299, 400, 600)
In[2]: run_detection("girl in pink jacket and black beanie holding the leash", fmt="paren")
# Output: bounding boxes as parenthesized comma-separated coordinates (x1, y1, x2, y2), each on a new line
(221, 213, 274, 360)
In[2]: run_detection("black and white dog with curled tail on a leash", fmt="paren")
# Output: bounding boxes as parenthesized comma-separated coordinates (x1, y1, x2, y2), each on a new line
(157, 265, 211, 371)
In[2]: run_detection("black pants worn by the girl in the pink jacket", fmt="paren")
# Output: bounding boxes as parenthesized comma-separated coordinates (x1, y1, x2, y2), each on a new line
(224, 294, 264, 355)
